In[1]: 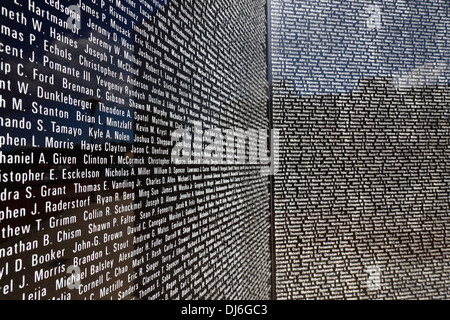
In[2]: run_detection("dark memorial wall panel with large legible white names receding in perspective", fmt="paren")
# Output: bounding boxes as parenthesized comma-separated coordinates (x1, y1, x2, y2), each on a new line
(0, 0, 271, 300)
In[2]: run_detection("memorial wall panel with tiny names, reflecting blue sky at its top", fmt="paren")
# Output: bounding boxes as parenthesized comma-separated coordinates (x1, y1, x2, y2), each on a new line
(271, 0, 450, 299)
